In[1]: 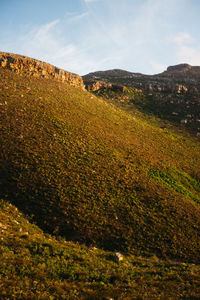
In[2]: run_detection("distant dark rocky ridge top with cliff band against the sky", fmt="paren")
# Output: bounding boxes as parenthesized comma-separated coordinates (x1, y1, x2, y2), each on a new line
(83, 64, 200, 94)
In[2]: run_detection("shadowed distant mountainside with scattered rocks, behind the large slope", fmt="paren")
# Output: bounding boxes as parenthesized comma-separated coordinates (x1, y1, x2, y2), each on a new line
(83, 64, 200, 136)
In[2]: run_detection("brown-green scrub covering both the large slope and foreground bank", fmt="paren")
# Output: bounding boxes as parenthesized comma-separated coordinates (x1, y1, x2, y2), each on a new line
(0, 69, 200, 299)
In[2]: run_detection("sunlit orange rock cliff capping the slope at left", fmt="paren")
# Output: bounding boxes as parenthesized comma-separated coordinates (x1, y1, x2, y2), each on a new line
(0, 52, 85, 89)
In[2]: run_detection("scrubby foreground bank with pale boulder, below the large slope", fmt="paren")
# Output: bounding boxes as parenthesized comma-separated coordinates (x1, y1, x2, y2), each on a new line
(0, 200, 200, 300)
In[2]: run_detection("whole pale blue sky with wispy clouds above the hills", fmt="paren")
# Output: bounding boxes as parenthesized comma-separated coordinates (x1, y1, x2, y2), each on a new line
(0, 0, 200, 75)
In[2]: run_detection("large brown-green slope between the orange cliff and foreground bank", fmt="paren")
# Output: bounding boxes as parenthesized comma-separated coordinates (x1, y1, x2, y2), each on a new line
(0, 69, 200, 261)
